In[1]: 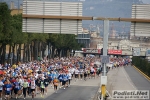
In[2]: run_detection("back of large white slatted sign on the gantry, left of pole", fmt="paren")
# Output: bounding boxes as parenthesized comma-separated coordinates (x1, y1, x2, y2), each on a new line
(22, 0, 82, 34)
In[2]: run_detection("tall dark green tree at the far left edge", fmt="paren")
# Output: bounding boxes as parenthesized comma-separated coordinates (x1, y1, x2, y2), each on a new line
(0, 3, 11, 63)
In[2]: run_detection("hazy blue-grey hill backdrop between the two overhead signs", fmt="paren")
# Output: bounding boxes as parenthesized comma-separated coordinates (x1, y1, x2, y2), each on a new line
(0, 0, 143, 31)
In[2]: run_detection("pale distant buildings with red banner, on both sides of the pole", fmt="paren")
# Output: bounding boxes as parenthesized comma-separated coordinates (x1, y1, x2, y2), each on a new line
(90, 38, 150, 56)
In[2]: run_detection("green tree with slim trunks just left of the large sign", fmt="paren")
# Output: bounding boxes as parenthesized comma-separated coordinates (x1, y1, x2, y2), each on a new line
(8, 14, 28, 62)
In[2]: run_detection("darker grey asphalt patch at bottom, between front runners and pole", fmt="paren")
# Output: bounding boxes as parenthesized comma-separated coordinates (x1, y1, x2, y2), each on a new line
(45, 85, 98, 100)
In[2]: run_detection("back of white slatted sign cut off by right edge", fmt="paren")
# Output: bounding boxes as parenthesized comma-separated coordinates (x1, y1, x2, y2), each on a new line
(130, 4, 150, 39)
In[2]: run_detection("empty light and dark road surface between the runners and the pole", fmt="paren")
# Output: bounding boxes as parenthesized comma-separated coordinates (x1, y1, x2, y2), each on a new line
(8, 77, 100, 100)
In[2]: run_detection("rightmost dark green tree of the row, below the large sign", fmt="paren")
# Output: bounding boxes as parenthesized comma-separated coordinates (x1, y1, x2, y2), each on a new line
(48, 34, 81, 57)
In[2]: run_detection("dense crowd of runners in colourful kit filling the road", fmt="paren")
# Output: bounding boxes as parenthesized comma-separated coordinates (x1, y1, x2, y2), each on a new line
(0, 56, 131, 100)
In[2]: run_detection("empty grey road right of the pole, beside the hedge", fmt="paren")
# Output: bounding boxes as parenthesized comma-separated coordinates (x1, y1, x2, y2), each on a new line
(108, 66, 150, 100)
